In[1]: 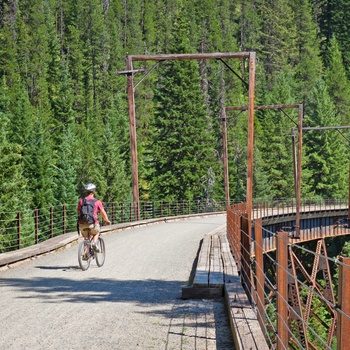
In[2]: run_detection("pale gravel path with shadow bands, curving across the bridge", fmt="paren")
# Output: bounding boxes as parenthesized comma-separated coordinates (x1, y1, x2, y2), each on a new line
(0, 215, 233, 350)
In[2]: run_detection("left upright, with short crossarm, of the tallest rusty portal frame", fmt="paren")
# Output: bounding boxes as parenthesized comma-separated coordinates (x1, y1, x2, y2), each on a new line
(126, 56, 140, 221)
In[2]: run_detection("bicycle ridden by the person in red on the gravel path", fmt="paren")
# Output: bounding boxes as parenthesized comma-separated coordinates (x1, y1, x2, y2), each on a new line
(78, 234, 106, 271)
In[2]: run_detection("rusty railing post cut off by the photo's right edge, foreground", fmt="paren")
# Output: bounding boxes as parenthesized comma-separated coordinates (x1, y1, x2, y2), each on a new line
(337, 256, 350, 350)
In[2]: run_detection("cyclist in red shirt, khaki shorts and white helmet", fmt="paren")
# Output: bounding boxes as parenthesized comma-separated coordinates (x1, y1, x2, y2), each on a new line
(78, 183, 111, 252)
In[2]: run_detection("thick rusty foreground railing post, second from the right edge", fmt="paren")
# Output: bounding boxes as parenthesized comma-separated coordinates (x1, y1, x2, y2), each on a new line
(276, 231, 289, 350)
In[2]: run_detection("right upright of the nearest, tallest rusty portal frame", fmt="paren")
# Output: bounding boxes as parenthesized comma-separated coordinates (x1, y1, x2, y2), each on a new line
(247, 52, 255, 235)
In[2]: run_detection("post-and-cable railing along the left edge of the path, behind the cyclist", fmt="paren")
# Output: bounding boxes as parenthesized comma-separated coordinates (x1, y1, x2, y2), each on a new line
(0, 200, 226, 253)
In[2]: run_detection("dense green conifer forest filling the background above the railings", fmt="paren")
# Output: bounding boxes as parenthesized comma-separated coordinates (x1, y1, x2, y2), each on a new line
(0, 0, 350, 212)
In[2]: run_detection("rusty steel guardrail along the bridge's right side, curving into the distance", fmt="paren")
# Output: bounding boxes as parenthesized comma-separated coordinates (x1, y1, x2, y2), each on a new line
(227, 200, 350, 350)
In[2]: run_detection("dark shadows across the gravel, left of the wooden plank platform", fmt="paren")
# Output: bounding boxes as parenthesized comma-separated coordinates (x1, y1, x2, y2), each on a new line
(0, 276, 189, 304)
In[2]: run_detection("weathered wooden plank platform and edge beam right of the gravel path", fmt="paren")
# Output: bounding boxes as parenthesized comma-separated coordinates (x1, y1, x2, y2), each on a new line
(182, 226, 268, 350)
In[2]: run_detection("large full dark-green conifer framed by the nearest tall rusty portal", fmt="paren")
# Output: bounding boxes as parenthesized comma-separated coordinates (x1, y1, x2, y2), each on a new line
(151, 7, 213, 200)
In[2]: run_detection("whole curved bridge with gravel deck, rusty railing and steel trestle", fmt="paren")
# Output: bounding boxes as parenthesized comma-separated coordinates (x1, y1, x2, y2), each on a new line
(0, 198, 350, 349)
